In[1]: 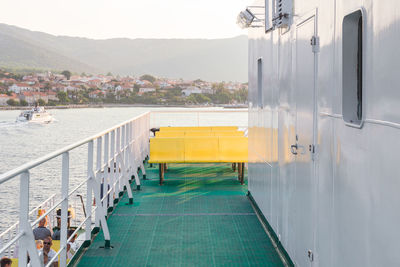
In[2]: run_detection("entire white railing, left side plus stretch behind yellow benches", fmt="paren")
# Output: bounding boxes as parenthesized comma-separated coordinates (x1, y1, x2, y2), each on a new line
(0, 109, 248, 266)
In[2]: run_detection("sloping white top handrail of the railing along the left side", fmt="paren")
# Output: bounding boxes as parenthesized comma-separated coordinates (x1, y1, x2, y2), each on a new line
(0, 112, 149, 184)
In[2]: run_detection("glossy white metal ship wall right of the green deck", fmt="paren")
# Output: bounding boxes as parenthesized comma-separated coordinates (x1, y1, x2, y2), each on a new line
(248, 0, 400, 267)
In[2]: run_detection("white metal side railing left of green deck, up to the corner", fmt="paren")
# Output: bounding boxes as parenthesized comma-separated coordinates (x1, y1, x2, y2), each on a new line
(0, 113, 150, 267)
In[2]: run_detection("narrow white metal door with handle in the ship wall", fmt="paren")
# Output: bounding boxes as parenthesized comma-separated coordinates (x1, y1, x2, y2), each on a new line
(291, 16, 318, 266)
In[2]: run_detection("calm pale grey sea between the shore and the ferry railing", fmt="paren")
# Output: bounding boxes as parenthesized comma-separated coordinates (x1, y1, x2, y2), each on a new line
(0, 107, 247, 233)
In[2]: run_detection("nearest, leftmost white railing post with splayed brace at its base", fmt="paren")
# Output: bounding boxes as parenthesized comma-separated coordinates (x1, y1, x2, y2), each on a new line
(18, 171, 41, 266)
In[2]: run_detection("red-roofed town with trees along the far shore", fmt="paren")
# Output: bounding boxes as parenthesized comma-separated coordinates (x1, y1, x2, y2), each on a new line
(0, 69, 248, 108)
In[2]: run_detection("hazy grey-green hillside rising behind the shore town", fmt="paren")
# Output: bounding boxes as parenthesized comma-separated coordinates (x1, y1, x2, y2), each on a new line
(0, 24, 247, 82)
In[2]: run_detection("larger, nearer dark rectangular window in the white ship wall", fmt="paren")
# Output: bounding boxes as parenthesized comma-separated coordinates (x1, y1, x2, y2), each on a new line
(342, 10, 363, 127)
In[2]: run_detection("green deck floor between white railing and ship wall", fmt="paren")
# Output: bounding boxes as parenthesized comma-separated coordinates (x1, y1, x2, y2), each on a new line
(78, 164, 283, 267)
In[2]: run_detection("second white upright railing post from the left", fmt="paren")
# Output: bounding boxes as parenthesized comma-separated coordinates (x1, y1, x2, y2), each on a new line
(60, 152, 69, 267)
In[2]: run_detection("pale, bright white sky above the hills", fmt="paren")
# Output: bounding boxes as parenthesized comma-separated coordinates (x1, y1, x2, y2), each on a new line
(0, 0, 250, 39)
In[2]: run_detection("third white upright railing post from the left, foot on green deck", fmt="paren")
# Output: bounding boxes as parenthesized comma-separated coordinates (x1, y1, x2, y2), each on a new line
(83, 140, 93, 247)
